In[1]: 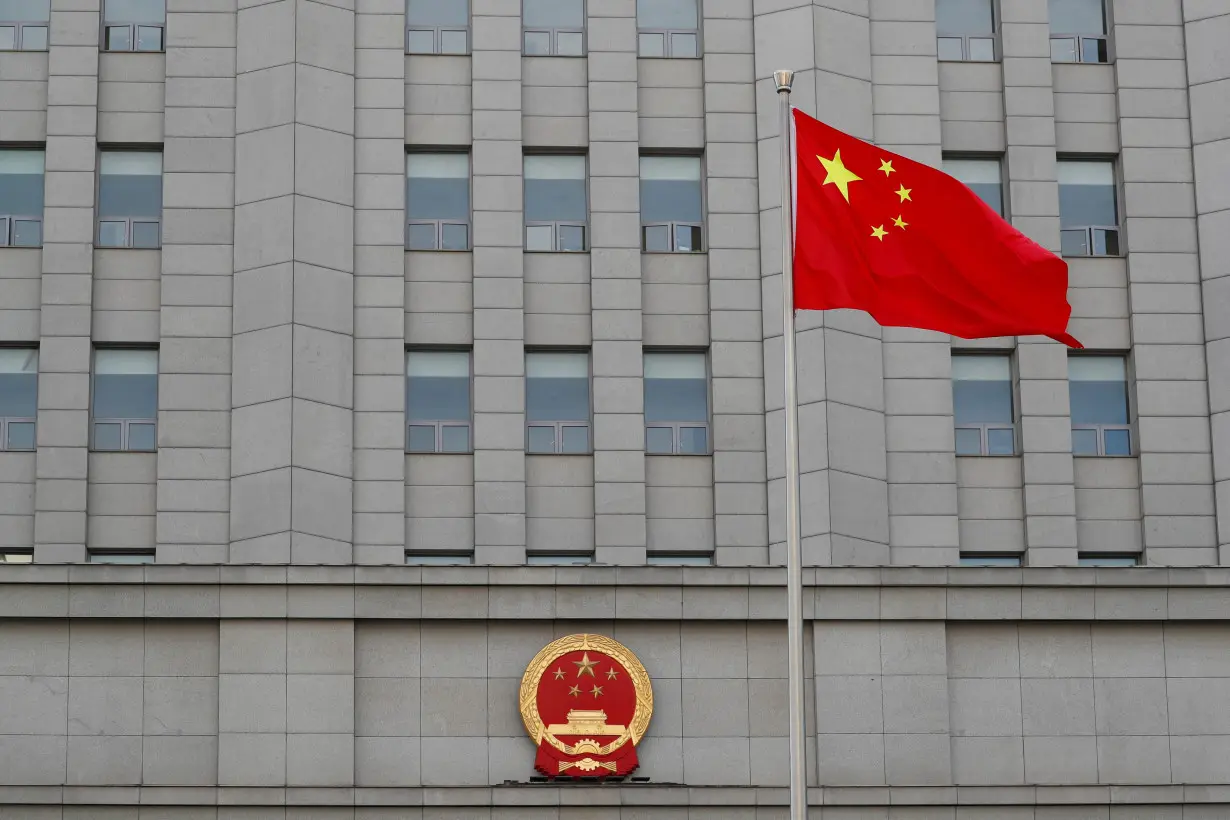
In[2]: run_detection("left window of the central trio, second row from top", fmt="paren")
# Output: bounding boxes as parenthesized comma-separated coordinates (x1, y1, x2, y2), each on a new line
(406, 152, 470, 251)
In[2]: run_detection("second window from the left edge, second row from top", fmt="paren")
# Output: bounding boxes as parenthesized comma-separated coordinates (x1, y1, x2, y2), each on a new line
(98, 150, 162, 248)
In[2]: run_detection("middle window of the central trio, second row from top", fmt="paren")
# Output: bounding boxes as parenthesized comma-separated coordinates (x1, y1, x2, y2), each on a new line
(524, 155, 589, 251)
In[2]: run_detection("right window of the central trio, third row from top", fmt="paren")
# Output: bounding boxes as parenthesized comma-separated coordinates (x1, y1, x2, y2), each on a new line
(645, 353, 708, 455)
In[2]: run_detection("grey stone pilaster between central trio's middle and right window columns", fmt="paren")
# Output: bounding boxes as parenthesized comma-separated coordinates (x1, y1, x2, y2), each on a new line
(588, 0, 646, 564)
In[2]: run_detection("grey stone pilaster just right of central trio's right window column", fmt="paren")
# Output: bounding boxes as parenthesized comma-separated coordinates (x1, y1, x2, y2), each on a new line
(704, 0, 769, 566)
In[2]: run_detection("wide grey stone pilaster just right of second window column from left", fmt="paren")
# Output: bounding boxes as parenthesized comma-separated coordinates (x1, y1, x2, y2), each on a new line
(156, 0, 236, 564)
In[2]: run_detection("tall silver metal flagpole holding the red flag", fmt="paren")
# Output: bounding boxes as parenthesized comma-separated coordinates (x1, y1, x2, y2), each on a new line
(772, 70, 807, 820)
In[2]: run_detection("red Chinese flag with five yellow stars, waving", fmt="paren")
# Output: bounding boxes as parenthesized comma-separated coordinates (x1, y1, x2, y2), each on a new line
(795, 111, 1081, 348)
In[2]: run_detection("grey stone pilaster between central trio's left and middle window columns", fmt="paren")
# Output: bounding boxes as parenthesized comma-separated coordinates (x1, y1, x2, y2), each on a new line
(471, 0, 525, 564)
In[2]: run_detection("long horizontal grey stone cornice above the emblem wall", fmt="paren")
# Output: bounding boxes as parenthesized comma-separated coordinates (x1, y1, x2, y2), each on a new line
(0, 564, 1230, 621)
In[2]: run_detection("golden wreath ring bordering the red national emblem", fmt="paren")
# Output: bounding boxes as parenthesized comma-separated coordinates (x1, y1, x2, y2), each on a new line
(520, 632, 653, 755)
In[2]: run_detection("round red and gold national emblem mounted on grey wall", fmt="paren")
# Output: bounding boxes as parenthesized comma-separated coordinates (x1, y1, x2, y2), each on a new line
(520, 634, 653, 777)
